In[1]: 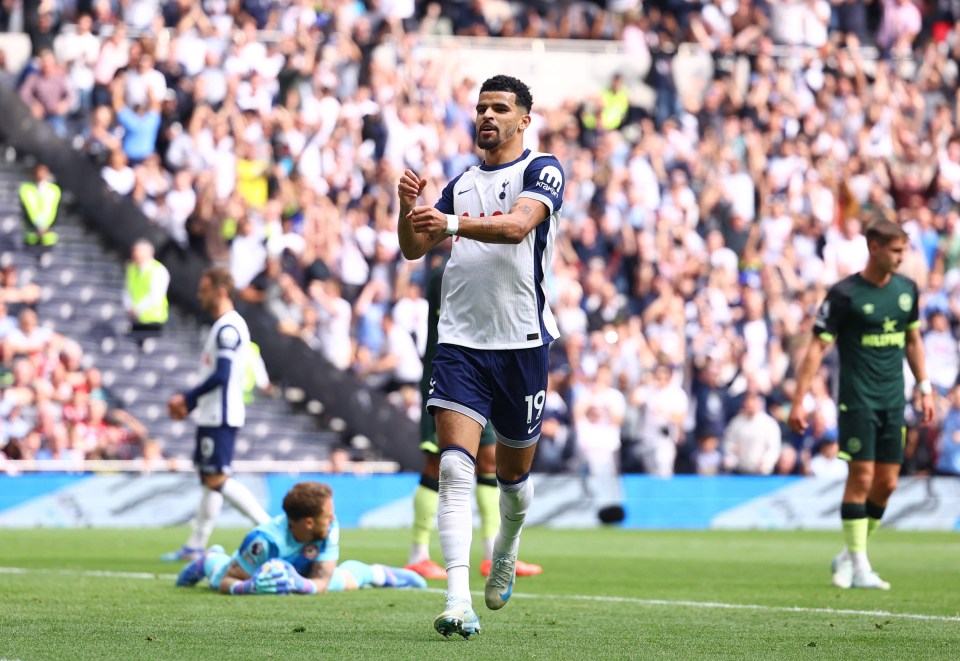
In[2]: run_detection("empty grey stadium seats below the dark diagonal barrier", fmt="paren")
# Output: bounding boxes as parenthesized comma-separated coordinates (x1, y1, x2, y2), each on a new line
(0, 163, 340, 460)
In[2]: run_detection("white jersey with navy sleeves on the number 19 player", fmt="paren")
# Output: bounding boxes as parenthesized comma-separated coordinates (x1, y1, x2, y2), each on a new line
(436, 149, 564, 349)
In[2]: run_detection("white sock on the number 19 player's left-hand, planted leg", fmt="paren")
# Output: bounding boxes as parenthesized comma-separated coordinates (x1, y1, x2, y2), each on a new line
(437, 450, 476, 603)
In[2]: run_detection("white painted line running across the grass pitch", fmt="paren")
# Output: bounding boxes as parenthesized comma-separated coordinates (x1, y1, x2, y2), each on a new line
(0, 567, 960, 623)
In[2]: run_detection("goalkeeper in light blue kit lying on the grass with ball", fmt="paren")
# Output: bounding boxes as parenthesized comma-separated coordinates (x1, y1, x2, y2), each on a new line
(177, 482, 426, 594)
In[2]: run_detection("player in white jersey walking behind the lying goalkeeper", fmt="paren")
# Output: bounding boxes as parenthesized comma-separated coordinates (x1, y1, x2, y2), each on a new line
(162, 269, 270, 562)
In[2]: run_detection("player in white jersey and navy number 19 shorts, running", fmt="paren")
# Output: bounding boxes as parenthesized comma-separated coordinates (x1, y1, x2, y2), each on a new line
(398, 76, 564, 638)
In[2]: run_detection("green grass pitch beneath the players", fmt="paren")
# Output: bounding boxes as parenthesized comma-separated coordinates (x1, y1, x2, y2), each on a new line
(0, 529, 960, 661)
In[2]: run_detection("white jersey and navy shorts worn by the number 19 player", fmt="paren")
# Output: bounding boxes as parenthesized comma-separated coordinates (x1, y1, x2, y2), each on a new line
(427, 149, 564, 447)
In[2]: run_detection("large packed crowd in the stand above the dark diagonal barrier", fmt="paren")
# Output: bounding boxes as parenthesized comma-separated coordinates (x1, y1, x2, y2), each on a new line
(0, 0, 960, 475)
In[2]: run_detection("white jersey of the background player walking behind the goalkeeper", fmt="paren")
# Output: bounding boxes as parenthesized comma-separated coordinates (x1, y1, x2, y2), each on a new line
(194, 310, 250, 427)
